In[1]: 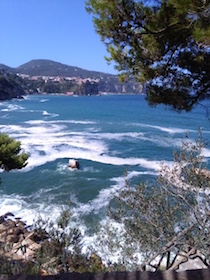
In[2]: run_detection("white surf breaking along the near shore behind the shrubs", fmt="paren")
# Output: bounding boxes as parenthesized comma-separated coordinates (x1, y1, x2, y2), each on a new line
(0, 192, 141, 264)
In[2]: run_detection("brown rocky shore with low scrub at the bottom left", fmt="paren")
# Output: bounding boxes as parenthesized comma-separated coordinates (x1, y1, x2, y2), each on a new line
(0, 212, 105, 279)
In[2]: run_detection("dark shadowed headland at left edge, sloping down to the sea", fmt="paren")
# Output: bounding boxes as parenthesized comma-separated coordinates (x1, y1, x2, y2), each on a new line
(0, 71, 26, 100)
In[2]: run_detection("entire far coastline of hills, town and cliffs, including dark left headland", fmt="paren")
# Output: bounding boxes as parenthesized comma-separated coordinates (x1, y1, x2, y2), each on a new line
(0, 60, 145, 100)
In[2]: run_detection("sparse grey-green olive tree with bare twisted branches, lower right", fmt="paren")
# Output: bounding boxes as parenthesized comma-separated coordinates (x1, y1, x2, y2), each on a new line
(101, 133, 210, 270)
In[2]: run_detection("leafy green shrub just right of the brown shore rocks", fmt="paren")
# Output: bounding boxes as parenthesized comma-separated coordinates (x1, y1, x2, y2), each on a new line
(34, 208, 108, 274)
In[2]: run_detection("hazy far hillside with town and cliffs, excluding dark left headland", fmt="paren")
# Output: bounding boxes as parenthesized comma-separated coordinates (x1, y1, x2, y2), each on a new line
(0, 59, 143, 95)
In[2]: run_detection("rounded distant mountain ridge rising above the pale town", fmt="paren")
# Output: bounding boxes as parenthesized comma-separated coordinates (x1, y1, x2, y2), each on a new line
(16, 59, 117, 79)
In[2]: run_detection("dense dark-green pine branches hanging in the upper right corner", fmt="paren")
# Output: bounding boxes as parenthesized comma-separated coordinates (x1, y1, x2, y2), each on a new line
(86, 0, 210, 111)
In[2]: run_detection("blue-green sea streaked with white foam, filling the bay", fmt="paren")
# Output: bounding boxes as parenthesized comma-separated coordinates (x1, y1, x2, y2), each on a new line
(0, 94, 210, 260)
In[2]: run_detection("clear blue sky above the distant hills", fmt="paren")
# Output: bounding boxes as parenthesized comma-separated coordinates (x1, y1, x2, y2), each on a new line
(0, 0, 117, 74)
